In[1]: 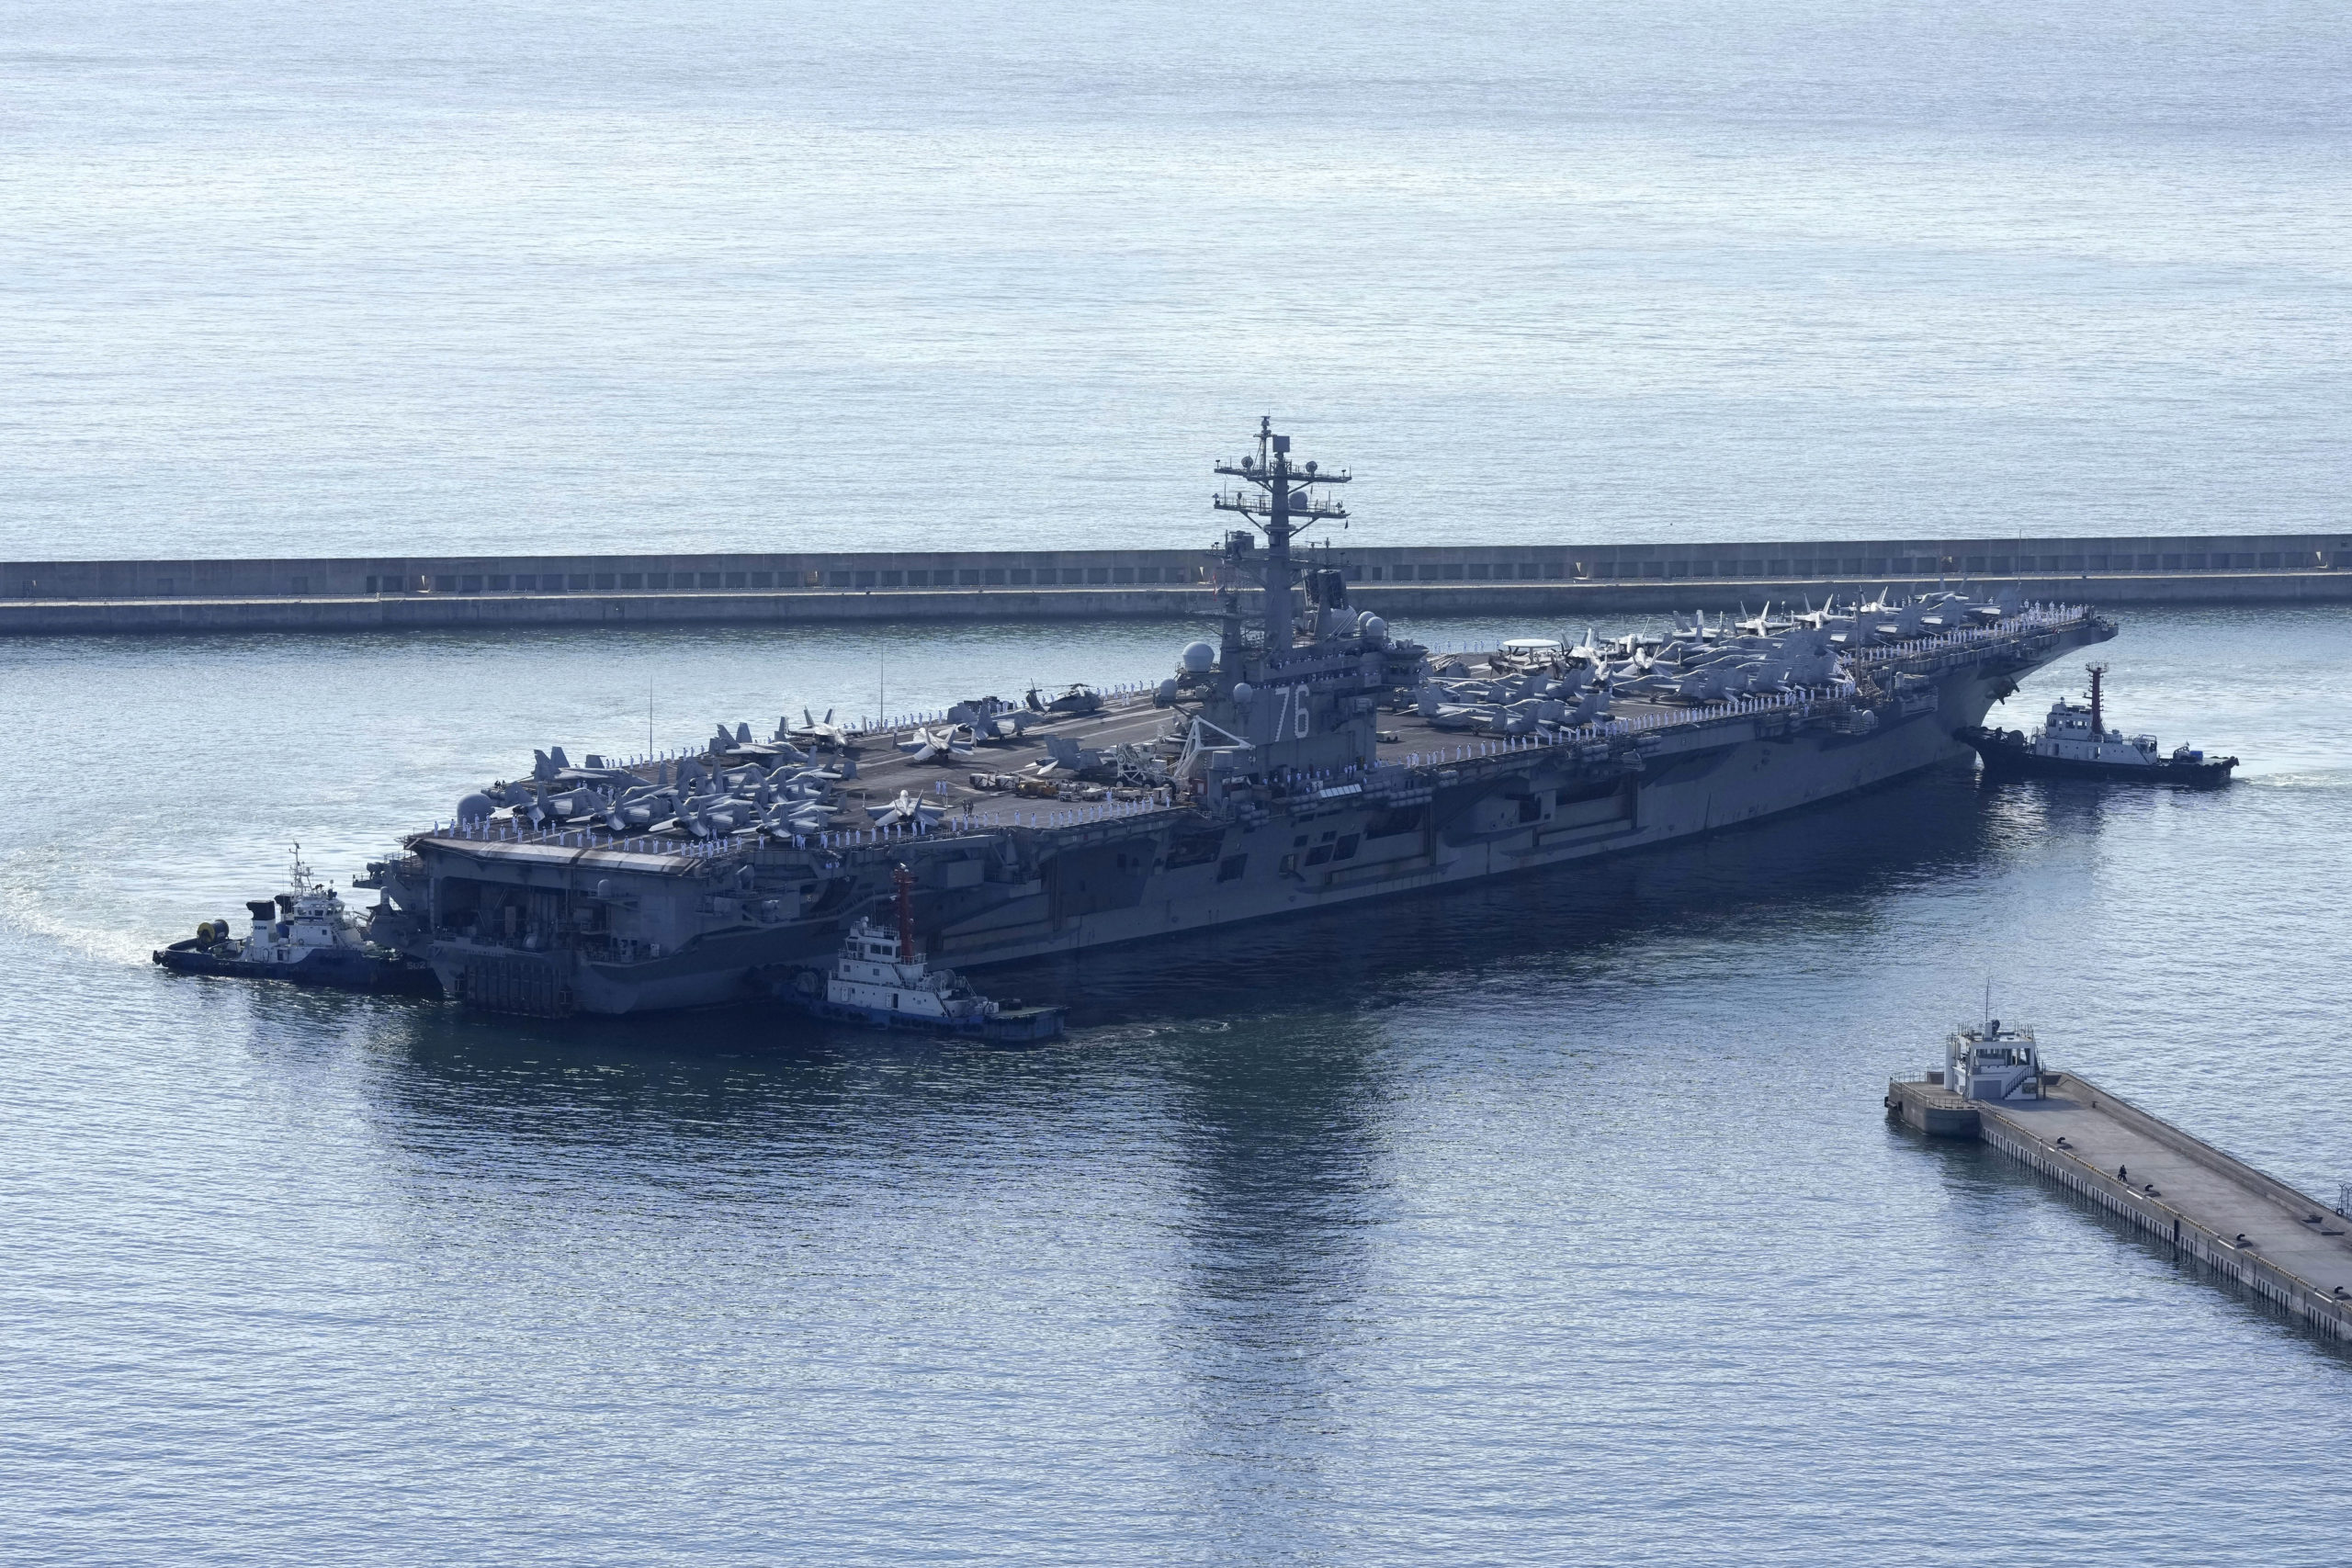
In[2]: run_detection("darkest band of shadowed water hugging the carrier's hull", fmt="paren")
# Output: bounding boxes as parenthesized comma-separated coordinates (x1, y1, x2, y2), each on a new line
(322, 771, 2031, 1147)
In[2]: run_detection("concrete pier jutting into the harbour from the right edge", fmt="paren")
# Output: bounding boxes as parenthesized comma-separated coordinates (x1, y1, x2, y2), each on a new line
(1886, 1072, 2352, 1345)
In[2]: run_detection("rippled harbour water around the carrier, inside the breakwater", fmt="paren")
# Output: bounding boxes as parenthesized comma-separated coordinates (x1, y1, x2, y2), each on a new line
(0, 611, 2352, 1563)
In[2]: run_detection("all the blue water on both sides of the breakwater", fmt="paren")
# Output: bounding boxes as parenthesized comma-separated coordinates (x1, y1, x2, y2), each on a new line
(0, 0, 2352, 1568)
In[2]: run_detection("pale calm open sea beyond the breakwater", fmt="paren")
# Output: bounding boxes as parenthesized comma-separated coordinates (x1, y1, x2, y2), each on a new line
(0, 0, 2352, 559)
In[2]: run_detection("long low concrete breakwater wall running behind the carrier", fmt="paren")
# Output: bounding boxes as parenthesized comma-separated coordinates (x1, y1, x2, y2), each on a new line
(0, 534, 2352, 635)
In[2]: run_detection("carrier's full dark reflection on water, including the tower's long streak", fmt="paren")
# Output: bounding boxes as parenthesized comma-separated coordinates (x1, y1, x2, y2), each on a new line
(303, 771, 2034, 1556)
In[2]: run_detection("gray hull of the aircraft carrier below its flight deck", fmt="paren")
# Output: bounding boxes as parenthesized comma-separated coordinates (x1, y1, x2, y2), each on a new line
(383, 616, 2112, 1016)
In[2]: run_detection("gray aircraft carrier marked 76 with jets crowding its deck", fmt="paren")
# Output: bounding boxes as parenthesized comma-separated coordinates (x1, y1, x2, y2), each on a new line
(360, 421, 2114, 1016)
